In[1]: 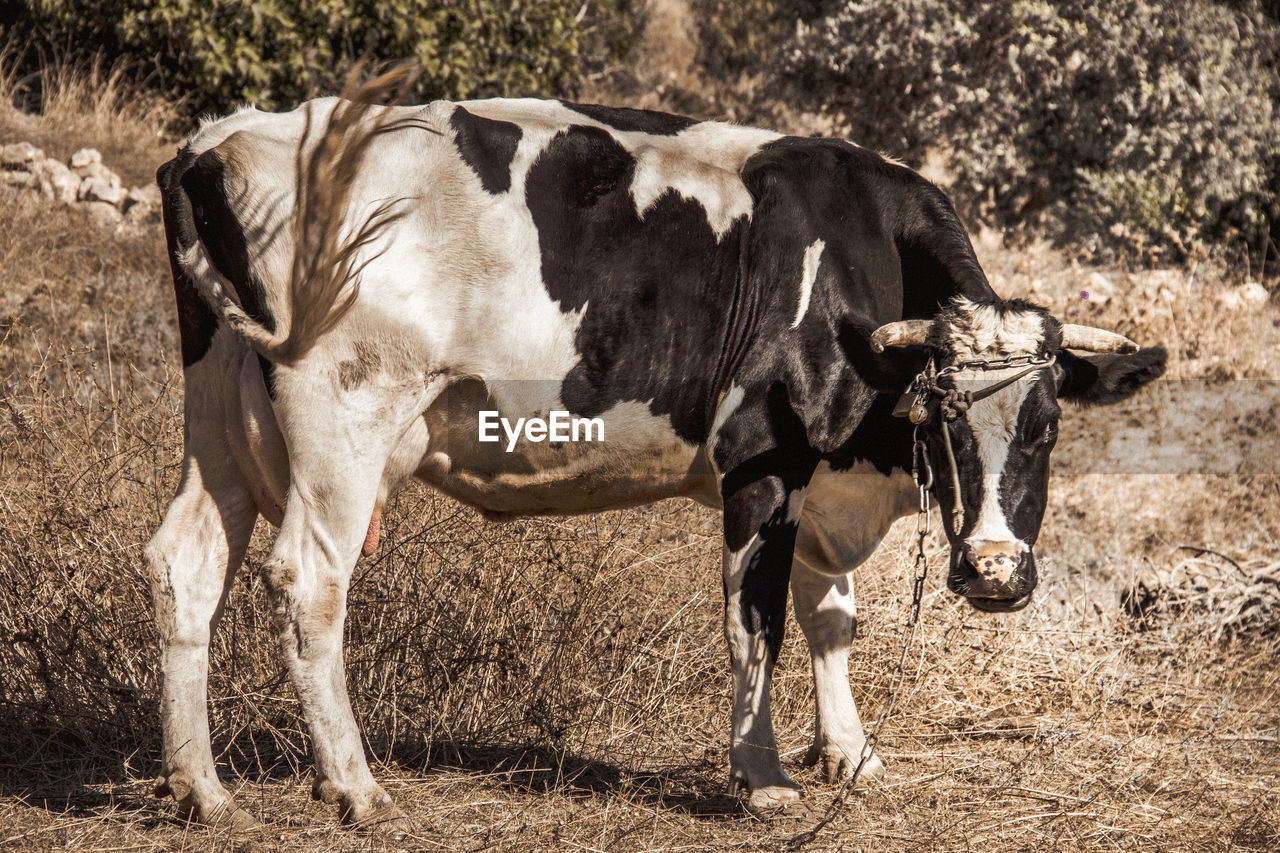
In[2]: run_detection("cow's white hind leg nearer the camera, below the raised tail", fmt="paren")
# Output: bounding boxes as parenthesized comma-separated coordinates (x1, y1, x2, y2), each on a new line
(254, 370, 443, 830)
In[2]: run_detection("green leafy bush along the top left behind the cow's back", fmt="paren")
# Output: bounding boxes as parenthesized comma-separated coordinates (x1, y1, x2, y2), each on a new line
(0, 0, 640, 109)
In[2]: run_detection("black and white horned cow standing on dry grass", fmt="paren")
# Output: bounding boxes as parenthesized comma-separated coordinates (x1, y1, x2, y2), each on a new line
(146, 91, 1165, 825)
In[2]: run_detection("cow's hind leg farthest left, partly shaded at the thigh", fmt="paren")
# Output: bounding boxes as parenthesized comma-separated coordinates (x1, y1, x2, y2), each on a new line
(145, 427, 257, 829)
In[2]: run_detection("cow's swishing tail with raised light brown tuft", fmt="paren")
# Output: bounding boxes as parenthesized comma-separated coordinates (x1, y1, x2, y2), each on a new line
(159, 65, 419, 362)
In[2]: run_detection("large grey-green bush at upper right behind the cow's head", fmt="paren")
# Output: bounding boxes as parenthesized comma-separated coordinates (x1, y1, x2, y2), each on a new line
(778, 0, 1280, 258)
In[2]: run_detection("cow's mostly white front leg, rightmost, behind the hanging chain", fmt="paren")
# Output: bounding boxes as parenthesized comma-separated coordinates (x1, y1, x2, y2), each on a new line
(791, 560, 884, 781)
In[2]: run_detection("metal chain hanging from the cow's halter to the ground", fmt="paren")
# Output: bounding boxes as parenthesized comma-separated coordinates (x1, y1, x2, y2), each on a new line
(780, 435, 933, 850)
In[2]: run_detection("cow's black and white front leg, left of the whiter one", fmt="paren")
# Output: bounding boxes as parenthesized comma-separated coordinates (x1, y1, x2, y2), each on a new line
(723, 475, 804, 812)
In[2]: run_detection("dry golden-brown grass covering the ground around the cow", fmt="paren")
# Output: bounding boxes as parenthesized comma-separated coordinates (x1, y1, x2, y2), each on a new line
(0, 43, 1280, 850)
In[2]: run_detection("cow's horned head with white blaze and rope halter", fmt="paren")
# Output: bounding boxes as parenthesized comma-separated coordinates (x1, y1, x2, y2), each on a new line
(872, 297, 1165, 611)
